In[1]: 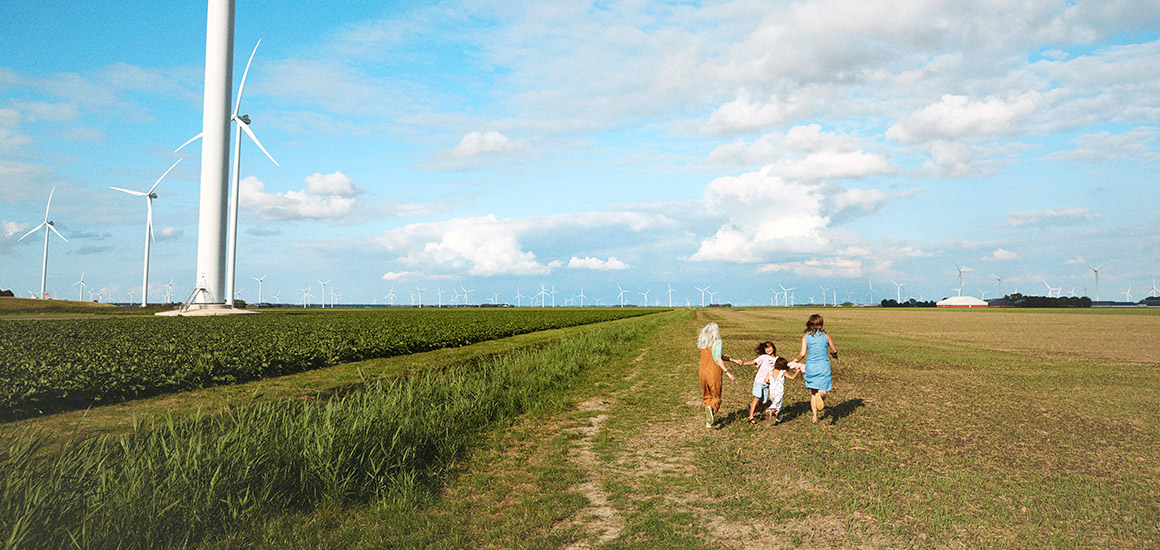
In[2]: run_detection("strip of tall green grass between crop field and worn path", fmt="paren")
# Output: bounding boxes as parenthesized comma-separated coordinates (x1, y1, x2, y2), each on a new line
(0, 318, 658, 548)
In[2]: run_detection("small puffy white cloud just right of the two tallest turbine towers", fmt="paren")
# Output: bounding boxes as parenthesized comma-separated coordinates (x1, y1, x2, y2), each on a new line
(239, 172, 362, 219)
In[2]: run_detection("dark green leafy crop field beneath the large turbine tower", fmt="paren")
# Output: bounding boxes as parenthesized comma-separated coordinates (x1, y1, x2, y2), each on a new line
(0, 309, 647, 420)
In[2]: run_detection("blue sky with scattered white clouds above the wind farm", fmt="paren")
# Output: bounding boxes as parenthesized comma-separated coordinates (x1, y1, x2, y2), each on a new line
(0, 0, 1160, 305)
